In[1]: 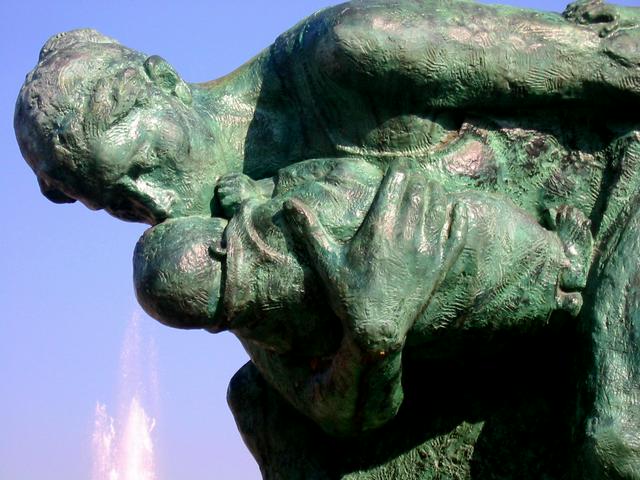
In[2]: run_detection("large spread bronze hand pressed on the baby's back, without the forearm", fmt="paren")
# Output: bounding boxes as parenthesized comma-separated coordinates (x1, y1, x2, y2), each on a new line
(284, 165, 467, 355)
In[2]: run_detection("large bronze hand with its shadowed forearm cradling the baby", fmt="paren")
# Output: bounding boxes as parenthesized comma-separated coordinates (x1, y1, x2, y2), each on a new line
(244, 162, 466, 435)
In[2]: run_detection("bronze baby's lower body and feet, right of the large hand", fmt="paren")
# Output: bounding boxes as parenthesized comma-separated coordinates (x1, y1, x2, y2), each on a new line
(408, 195, 593, 344)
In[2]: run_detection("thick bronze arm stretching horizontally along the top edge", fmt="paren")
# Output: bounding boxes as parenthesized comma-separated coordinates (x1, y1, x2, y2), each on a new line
(275, 0, 640, 109)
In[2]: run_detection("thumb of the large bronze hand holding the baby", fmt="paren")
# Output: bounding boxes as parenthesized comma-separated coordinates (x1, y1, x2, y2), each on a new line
(282, 198, 340, 276)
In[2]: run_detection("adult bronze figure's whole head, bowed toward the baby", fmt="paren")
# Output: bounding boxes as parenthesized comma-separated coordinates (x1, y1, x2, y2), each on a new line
(15, 30, 224, 224)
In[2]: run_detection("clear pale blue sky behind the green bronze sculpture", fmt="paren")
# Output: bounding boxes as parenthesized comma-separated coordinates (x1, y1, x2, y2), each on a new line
(0, 0, 640, 480)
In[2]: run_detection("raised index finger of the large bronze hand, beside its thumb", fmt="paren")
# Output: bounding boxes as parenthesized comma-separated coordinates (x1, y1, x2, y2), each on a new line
(358, 161, 409, 242)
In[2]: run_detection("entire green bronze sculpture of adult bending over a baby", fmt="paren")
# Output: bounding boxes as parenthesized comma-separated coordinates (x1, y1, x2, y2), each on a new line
(15, 0, 640, 479)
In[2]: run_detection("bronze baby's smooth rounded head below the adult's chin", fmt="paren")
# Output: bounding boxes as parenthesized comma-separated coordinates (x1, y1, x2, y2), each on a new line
(133, 217, 227, 331)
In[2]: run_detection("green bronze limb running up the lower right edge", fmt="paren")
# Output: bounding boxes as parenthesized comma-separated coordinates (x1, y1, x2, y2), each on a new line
(576, 195, 640, 480)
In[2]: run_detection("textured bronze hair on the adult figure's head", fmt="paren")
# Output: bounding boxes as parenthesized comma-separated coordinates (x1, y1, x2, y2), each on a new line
(14, 29, 141, 203)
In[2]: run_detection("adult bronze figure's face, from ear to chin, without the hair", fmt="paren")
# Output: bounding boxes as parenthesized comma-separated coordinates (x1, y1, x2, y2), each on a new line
(58, 52, 215, 224)
